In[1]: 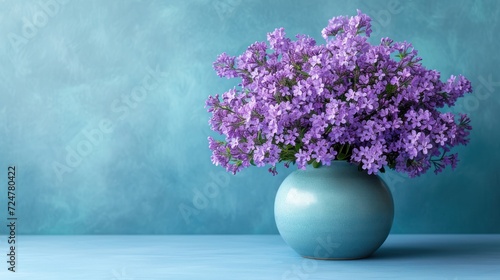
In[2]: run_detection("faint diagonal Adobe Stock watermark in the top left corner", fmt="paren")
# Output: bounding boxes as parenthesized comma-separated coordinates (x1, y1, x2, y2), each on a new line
(7, 0, 69, 52)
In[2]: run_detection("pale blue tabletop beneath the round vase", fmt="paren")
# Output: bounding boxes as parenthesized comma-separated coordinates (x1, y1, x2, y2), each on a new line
(0, 234, 500, 280)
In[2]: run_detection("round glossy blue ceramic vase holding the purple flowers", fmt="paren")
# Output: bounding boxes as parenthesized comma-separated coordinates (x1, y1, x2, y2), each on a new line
(274, 161, 394, 259)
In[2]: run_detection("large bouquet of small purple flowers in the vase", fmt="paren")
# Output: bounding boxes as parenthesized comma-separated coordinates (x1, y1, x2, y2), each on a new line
(206, 10, 472, 177)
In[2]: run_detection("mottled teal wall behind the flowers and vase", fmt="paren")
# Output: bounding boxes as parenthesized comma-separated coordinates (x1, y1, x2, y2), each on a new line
(0, 0, 500, 234)
